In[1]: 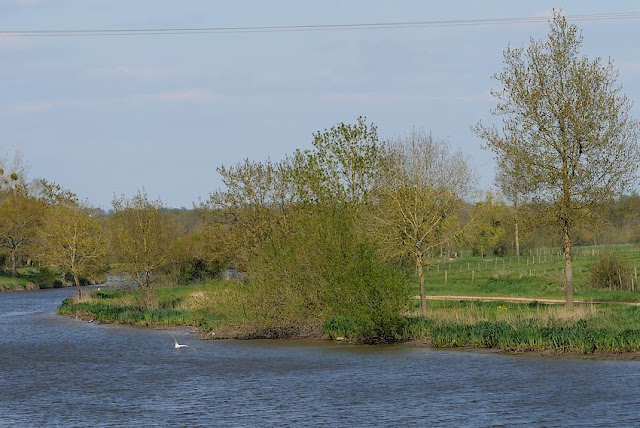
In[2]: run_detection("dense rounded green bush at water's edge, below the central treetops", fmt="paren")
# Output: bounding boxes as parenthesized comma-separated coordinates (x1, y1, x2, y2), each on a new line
(246, 207, 409, 342)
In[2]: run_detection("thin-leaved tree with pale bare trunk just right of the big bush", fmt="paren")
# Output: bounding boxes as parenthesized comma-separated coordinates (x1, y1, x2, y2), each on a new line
(366, 131, 473, 313)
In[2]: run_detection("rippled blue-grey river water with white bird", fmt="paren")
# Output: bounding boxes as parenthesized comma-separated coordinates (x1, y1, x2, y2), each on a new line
(0, 289, 640, 427)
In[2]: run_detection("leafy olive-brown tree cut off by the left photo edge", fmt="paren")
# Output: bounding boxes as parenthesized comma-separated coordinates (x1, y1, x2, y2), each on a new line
(0, 189, 45, 277)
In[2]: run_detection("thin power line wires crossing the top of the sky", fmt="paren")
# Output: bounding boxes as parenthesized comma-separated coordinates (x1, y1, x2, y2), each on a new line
(0, 12, 640, 37)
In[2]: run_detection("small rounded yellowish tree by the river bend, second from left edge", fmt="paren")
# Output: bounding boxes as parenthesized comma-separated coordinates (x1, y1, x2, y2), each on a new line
(39, 204, 109, 296)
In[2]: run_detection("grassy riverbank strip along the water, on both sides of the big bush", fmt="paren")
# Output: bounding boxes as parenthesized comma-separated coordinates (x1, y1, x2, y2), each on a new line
(58, 283, 640, 358)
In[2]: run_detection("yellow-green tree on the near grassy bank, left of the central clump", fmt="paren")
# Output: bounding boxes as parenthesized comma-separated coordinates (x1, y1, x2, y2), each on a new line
(110, 191, 180, 307)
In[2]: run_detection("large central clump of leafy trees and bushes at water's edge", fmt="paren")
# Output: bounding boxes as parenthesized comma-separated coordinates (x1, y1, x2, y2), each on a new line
(205, 118, 408, 341)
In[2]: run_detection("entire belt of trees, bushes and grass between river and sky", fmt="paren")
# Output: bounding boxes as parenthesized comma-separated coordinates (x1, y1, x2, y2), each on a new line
(6, 13, 640, 352)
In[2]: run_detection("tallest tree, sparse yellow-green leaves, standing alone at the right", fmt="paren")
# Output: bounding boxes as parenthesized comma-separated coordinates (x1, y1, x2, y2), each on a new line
(474, 12, 640, 306)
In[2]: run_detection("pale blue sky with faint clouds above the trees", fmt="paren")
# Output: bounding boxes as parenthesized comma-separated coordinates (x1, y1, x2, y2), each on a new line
(0, 0, 640, 209)
